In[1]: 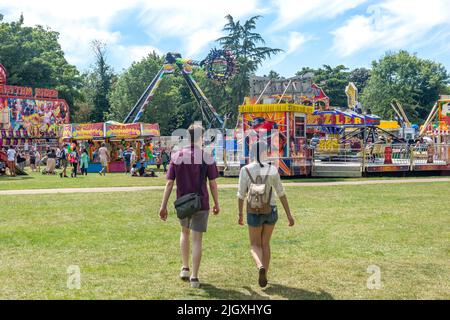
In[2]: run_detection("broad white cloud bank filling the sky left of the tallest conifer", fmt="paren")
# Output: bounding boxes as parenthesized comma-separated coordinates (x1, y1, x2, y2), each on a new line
(0, 0, 267, 68)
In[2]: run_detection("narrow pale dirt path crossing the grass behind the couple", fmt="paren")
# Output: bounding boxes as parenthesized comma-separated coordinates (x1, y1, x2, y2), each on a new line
(0, 178, 450, 195)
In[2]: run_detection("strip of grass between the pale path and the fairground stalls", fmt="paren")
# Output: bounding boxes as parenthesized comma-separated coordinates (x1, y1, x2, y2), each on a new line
(0, 170, 445, 190)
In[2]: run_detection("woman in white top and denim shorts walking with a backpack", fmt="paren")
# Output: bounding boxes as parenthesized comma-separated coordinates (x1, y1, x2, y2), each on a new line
(237, 141, 294, 287)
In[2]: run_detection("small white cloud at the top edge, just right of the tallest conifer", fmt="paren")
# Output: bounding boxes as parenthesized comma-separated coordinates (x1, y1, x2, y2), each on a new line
(272, 0, 368, 30)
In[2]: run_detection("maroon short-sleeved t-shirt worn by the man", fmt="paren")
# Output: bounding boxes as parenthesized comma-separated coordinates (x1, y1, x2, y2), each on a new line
(167, 146, 219, 210)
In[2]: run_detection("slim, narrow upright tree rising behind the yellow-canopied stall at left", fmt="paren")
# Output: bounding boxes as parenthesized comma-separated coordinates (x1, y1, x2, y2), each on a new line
(90, 40, 114, 122)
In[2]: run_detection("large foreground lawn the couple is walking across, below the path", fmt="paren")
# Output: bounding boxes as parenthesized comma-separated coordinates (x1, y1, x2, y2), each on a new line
(0, 180, 450, 299)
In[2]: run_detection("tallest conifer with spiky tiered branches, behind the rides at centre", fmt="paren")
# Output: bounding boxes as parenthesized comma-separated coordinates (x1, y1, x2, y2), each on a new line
(216, 15, 282, 120)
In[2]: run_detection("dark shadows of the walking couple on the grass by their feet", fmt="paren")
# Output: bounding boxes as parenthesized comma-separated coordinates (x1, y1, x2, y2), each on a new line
(195, 283, 334, 300)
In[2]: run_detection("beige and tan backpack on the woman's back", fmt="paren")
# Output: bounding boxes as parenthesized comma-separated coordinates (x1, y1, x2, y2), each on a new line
(245, 165, 272, 214)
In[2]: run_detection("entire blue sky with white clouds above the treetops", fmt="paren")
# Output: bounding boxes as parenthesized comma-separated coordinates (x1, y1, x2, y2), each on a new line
(0, 0, 450, 77)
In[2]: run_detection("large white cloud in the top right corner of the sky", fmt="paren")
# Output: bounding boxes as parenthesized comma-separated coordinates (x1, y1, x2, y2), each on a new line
(333, 0, 450, 57)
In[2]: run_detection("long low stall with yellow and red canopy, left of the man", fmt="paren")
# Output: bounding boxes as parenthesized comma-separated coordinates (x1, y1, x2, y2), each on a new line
(62, 121, 160, 172)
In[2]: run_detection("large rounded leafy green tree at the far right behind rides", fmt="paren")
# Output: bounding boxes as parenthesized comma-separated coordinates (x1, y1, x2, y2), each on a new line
(362, 50, 449, 122)
